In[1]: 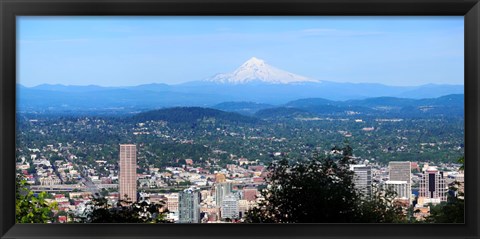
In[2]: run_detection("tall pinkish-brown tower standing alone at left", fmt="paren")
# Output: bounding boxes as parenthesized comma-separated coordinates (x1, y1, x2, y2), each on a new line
(119, 144, 137, 202)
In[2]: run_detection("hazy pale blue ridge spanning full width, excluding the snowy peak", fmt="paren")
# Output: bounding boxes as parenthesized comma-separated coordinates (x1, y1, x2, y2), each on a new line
(17, 82, 464, 110)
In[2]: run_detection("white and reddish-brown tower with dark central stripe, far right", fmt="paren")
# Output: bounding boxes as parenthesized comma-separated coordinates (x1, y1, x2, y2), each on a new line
(419, 167, 448, 202)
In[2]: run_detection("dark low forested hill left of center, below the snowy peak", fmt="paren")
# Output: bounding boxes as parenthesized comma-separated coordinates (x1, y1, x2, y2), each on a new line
(132, 107, 261, 124)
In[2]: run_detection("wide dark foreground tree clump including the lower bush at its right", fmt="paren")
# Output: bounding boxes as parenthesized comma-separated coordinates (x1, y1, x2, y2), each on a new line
(244, 146, 404, 223)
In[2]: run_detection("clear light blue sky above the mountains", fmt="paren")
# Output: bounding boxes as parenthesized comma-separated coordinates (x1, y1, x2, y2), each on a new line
(17, 16, 464, 86)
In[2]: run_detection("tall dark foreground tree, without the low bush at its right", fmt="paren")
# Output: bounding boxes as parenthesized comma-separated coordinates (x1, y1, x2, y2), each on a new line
(245, 147, 359, 223)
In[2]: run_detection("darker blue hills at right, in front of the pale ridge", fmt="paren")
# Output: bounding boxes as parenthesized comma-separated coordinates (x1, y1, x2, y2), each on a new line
(254, 94, 465, 119)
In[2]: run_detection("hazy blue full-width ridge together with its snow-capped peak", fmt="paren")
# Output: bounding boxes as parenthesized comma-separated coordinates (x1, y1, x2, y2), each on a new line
(17, 57, 464, 114)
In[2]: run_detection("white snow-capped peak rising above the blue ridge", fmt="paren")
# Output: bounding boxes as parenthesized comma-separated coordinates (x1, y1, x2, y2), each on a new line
(207, 57, 320, 84)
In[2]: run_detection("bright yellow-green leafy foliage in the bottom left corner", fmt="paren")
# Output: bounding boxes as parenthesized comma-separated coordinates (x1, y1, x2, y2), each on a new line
(15, 175, 58, 223)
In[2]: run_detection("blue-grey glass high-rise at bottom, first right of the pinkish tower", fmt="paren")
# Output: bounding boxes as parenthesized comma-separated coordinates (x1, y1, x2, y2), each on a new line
(178, 188, 200, 223)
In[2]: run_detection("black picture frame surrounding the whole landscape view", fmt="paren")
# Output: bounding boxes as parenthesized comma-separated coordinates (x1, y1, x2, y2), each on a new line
(0, 0, 480, 239)
